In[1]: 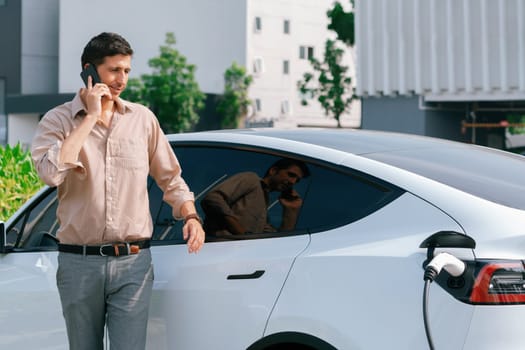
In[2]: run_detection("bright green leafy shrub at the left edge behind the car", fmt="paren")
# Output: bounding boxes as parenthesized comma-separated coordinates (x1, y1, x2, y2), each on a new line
(0, 144, 43, 221)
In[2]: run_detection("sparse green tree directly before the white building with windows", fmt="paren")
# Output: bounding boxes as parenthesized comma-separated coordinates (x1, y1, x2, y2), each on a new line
(297, 40, 355, 128)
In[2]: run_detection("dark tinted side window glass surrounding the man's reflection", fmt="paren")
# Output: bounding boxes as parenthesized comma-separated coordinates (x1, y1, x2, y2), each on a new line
(150, 145, 401, 244)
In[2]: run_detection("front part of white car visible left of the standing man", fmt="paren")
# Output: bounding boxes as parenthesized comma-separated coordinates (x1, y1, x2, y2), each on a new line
(0, 188, 68, 349)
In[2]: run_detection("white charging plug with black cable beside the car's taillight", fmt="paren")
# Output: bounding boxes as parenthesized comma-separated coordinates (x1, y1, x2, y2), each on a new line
(423, 253, 465, 350)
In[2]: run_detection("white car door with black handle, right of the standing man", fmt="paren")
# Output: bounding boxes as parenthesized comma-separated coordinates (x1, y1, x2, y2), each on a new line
(148, 146, 310, 349)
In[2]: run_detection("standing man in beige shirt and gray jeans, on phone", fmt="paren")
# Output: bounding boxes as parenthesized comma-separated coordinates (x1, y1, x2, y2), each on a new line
(32, 33, 204, 350)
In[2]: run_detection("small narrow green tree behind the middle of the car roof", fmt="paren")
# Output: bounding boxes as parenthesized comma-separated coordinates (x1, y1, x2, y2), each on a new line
(217, 62, 253, 129)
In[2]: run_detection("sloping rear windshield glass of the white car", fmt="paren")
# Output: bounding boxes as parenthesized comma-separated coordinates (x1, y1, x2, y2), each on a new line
(363, 147, 525, 210)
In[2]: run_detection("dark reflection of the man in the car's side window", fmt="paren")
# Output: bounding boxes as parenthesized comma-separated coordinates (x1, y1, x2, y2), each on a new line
(201, 158, 310, 236)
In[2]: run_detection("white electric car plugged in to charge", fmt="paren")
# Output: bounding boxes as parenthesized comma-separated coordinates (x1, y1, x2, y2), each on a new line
(0, 129, 525, 350)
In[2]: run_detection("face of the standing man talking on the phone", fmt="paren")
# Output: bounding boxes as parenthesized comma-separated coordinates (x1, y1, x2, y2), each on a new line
(97, 55, 131, 98)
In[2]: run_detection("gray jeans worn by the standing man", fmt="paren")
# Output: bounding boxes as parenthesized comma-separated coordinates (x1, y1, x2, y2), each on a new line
(57, 249, 153, 350)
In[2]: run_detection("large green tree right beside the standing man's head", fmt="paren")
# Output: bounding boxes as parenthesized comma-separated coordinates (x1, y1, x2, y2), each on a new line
(122, 33, 206, 133)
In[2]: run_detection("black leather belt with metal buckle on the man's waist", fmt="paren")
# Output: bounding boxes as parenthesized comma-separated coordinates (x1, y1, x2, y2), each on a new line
(58, 239, 150, 256)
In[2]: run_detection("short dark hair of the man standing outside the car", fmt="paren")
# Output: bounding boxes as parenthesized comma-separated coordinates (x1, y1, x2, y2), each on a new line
(80, 32, 133, 68)
